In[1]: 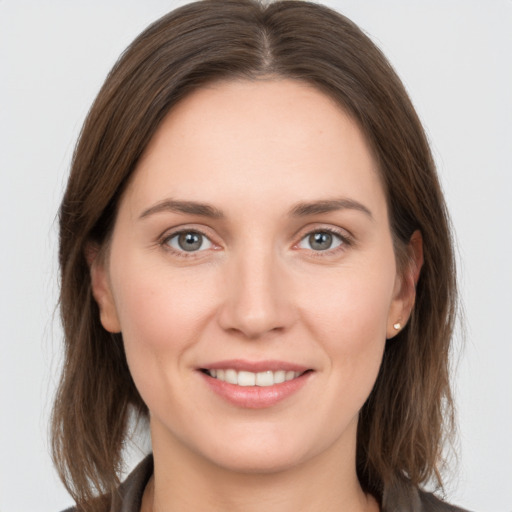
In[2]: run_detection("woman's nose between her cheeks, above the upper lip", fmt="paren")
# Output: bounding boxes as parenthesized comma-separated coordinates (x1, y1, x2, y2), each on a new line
(219, 248, 295, 339)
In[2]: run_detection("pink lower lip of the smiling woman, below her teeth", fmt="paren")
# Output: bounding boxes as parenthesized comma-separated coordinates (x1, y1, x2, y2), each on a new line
(200, 372, 313, 409)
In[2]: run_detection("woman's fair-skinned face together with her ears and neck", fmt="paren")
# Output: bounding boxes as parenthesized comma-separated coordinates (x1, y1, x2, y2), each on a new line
(91, 79, 421, 512)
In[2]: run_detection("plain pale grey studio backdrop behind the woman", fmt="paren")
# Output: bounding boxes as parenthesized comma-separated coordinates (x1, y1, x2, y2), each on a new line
(0, 0, 512, 512)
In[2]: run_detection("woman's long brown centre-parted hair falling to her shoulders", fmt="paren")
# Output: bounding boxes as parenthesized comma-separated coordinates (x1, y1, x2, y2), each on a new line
(52, 0, 456, 511)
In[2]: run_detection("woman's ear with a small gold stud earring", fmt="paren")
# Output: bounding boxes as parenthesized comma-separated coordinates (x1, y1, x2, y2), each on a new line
(386, 230, 423, 339)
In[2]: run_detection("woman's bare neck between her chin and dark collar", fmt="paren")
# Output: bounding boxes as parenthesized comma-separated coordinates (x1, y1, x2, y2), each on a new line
(142, 420, 379, 512)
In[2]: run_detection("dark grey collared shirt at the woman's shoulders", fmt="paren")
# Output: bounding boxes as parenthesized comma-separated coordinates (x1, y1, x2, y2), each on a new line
(64, 455, 468, 512)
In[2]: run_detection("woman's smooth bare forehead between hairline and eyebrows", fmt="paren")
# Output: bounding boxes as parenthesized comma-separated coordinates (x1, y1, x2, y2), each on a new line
(121, 79, 383, 219)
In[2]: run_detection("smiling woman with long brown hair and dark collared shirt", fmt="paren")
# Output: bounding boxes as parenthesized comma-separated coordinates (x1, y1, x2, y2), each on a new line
(53, 0, 468, 512)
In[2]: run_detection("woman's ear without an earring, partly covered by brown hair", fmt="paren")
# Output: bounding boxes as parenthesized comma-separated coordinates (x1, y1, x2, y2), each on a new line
(85, 244, 121, 333)
